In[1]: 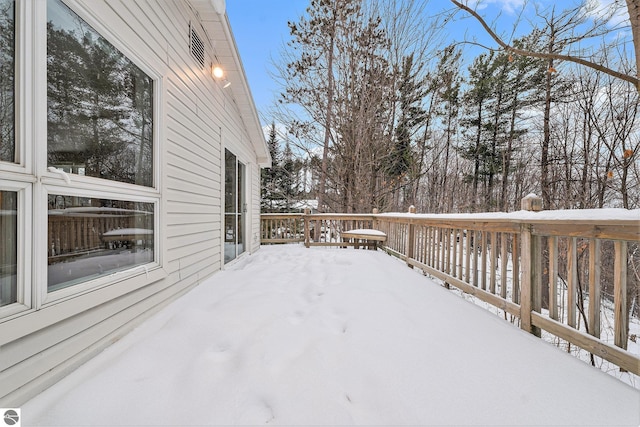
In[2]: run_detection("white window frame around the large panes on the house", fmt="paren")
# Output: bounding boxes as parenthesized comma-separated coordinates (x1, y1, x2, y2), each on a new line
(0, 0, 168, 323)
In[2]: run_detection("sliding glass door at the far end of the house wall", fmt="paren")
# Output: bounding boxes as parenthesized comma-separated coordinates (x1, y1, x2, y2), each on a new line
(224, 149, 247, 264)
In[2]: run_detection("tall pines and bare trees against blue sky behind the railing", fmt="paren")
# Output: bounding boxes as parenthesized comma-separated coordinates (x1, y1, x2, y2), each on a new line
(263, 0, 640, 212)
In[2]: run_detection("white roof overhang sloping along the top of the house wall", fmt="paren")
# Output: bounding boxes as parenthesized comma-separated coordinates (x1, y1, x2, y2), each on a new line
(190, 0, 271, 167)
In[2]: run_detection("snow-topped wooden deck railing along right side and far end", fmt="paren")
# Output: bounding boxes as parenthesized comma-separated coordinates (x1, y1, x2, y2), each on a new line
(262, 197, 640, 375)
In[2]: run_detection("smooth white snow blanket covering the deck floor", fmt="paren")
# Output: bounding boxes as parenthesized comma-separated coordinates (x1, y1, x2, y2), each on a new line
(22, 245, 640, 426)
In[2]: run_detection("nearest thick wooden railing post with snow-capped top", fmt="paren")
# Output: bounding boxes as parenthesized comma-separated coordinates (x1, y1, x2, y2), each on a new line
(520, 194, 542, 337)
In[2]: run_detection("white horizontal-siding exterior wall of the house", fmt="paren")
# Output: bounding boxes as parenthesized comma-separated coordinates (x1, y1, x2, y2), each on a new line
(0, 0, 264, 407)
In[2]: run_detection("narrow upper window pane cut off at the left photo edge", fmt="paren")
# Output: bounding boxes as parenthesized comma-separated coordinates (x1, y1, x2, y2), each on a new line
(0, 0, 16, 162)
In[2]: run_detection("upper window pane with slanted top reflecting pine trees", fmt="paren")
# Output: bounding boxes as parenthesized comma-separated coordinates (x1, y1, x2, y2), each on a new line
(46, 0, 154, 187)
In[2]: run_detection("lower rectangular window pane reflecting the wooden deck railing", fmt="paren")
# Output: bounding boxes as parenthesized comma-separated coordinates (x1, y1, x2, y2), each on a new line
(47, 194, 154, 291)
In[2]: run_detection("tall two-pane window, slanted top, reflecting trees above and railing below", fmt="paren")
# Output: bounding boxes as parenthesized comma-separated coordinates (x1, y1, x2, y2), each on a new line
(46, 0, 157, 292)
